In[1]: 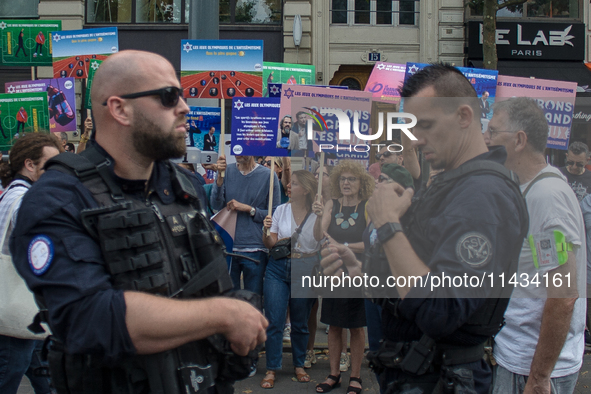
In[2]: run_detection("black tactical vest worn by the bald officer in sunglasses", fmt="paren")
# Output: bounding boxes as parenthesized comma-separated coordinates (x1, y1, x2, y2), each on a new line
(38, 147, 249, 394)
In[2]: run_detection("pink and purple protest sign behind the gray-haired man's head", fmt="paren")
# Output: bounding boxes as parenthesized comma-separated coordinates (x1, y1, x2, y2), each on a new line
(497, 75, 577, 150)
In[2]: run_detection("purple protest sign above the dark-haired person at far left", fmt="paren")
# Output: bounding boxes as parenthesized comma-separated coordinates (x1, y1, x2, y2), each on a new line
(4, 78, 77, 133)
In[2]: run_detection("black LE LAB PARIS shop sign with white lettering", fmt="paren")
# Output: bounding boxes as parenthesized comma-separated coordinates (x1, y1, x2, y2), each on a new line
(468, 21, 585, 60)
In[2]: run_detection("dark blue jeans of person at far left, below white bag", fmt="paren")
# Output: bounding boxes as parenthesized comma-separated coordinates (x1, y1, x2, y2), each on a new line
(0, 335, 51, 394)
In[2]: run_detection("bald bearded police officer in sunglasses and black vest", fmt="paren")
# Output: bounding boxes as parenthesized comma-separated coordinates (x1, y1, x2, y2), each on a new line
(10, 51, 267, 394)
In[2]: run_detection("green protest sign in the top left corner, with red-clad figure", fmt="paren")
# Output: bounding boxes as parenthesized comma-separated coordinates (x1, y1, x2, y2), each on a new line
(0, 19, 62, 67)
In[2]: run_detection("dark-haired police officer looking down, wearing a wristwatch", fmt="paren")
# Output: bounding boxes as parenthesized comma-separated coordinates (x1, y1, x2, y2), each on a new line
(322, 65, 527, 394)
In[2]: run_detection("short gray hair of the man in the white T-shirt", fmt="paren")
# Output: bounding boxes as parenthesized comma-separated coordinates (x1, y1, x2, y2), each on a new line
(493, 97, 548, 153)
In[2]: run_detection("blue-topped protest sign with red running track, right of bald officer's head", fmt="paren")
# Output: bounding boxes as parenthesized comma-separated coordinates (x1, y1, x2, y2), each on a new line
(181, 40, 263, 99)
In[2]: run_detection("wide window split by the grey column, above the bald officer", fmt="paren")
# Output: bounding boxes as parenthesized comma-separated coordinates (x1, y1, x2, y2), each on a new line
(86, 0, 282, 25)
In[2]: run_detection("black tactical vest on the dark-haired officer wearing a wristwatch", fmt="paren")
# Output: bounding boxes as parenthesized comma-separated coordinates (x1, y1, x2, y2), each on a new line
(366, 160, 529, 346)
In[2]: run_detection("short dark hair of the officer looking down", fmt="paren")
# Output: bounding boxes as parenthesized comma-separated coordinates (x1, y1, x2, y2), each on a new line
(400, 63, 480, 114)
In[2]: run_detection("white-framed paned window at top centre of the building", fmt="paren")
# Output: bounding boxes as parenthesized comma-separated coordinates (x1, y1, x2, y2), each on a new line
(331, 0, 419, 26)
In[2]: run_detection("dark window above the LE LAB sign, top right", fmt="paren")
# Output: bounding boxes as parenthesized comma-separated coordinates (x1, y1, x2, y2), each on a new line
(468, 0, 582, 19)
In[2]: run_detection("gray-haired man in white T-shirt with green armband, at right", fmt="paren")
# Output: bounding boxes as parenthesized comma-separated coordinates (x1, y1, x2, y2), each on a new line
(485, 97, 587, 394)
